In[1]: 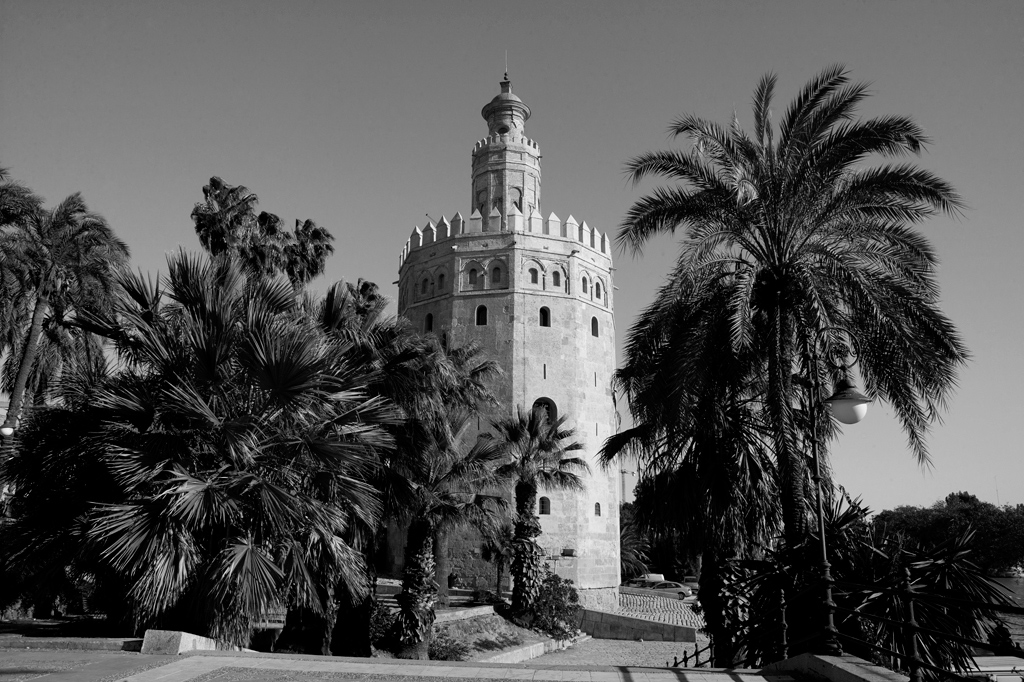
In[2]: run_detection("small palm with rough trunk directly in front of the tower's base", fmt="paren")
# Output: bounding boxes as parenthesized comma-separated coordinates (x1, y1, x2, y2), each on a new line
(482, 407, 590, 615)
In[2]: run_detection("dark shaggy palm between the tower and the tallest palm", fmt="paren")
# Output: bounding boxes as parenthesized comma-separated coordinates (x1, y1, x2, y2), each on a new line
(601, 267, 778, 666)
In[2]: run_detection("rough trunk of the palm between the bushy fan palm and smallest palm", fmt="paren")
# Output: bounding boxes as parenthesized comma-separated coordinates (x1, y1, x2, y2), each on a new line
(395, 518, 437, 660)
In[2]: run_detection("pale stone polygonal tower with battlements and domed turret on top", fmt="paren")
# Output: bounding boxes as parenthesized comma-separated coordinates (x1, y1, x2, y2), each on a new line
(398, 74, 620, 605)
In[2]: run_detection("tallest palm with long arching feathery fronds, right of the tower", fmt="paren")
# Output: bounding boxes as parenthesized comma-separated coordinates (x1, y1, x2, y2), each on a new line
(618, 67, 967, 545)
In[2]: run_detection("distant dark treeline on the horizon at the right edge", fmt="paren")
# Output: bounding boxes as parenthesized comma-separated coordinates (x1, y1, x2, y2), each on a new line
(874, 492, 1024, 573)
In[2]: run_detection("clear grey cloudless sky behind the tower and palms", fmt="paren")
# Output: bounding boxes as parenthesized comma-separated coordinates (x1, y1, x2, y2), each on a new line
(0, 0, 1024, 510)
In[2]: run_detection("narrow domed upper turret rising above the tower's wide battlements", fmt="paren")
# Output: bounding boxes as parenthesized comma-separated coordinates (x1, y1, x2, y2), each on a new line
(470, 74, 541, 230)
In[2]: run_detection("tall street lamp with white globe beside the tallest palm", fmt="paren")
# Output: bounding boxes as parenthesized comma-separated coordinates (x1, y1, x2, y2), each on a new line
(811, 366, 871, 656)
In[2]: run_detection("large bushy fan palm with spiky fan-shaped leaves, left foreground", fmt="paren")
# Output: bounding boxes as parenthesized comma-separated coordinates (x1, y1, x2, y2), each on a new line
(6, 254, 400, 649)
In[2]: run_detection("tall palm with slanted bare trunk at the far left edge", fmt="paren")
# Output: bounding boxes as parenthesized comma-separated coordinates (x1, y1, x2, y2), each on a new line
(0, 189, 128, 436)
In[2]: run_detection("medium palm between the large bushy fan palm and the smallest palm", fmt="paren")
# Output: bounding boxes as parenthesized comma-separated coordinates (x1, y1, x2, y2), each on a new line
(395, 410, 504, 658)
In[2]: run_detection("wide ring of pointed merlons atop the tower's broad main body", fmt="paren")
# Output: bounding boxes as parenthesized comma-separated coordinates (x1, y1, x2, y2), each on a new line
(398, 206, 611, 267)
